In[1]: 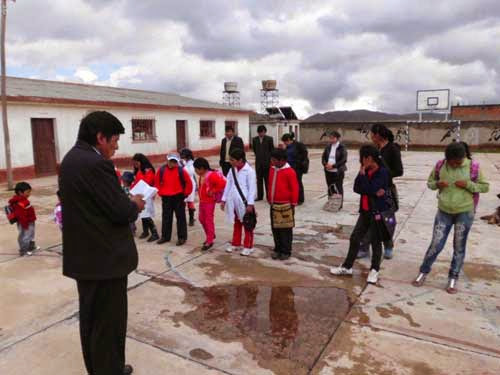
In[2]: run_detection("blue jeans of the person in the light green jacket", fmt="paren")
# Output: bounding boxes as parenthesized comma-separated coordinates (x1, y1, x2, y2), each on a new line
(420, 210, 474, 279)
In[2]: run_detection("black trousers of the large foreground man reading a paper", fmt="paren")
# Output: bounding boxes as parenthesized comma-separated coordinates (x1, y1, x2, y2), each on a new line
(76, 276, 128, 375)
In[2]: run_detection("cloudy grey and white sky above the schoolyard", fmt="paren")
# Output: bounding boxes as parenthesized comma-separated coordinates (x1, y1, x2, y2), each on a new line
(7, 0, 500, 118)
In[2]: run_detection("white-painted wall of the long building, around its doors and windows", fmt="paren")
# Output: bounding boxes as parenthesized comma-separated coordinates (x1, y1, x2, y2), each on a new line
(0, 104, 249, 180)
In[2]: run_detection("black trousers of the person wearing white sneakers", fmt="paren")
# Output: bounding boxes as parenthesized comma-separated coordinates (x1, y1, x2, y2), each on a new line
(342, 212, 382, 271)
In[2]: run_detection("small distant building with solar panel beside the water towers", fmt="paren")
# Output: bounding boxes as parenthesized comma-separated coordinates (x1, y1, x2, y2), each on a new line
(250, 107, 300, 146)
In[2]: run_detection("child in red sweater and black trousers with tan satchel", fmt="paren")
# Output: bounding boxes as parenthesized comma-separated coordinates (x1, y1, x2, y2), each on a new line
(267, 149, 299, 260)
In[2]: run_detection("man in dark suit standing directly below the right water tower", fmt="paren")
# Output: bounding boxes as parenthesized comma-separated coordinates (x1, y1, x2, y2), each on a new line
(252, 125, 274, 201)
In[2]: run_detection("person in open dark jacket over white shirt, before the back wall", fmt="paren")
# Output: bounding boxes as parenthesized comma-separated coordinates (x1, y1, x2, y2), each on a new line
(321, 130, 347, 208)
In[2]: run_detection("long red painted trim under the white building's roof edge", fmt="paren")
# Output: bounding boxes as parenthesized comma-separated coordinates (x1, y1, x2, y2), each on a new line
(7, 96, 254, 115)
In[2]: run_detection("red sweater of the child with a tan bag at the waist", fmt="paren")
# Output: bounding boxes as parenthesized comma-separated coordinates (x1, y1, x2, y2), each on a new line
(267, 164, 299, 205)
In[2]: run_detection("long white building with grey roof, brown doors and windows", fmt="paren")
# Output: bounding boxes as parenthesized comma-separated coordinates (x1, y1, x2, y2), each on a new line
(0, 77, 251, 181)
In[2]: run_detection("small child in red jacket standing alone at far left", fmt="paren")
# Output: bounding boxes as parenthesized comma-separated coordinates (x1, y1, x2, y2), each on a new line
(9, 182, 40, 256)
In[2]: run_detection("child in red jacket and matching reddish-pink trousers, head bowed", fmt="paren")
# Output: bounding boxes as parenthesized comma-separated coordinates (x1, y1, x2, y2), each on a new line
(193, 158, 226, 251)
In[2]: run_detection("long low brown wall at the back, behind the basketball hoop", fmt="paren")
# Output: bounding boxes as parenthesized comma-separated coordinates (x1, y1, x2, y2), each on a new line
(301, 121, 500, 149)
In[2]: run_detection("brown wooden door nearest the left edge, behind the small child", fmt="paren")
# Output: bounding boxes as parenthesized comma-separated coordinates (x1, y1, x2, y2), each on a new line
(31, 118, 57, 176)
